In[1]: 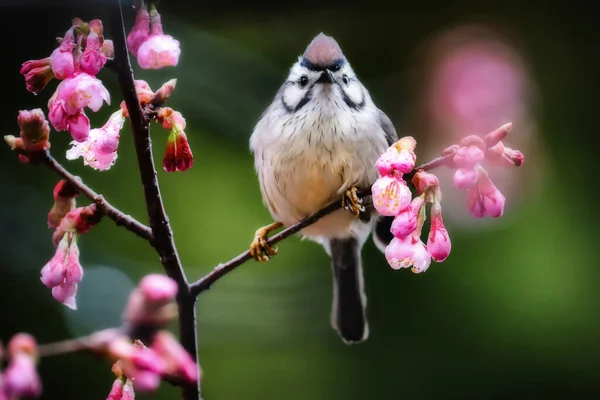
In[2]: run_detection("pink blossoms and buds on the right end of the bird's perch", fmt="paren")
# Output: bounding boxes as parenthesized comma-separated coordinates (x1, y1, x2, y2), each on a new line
(371, 124, 524, 273)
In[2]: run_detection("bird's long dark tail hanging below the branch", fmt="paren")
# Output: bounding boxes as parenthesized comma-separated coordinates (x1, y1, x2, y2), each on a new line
(329, 238, 369, 344)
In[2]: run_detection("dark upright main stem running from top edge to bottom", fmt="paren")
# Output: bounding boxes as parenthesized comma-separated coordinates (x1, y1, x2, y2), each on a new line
(110, 0, 201, 400)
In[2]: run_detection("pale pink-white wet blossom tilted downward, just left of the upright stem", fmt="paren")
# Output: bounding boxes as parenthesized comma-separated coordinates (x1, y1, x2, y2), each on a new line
(67, 109, 125, 171)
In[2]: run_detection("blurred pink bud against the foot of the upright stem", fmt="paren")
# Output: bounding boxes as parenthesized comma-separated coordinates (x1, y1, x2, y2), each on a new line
(152, 331, 199, 382)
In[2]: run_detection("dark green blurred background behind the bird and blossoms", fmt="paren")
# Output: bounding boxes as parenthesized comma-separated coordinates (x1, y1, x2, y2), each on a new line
(0, 0, 600, 399)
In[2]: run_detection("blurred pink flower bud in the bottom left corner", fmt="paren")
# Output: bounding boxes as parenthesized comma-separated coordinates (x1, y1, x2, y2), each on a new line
(2, 334, 42, 399)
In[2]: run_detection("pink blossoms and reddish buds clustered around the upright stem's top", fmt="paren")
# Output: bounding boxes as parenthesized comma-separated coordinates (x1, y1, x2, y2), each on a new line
(15, 8, 188, 172)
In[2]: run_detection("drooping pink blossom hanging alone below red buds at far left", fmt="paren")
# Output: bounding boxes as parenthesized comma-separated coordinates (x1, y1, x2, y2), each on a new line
(40, 233, 83, 310)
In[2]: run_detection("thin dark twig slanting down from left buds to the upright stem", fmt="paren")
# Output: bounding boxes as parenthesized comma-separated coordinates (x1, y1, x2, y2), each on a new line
(38, 151, 152, 242)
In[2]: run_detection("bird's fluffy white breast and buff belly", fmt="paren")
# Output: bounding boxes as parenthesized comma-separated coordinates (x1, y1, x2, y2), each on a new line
(251, 100, 387, 238)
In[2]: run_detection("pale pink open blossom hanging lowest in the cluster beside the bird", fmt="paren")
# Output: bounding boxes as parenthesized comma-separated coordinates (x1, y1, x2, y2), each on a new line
(385, 235, 431, 273)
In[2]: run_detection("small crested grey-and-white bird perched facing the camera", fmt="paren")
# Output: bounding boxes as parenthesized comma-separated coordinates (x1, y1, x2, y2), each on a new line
(250, 33, 398, 344)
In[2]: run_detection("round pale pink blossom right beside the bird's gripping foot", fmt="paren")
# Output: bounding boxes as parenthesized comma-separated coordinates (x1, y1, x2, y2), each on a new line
(371, 176, 412, 216)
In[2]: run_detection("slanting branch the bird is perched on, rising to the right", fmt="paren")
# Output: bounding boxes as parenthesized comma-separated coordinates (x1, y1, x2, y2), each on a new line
(190, 153, 454, 296)
